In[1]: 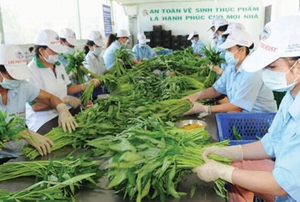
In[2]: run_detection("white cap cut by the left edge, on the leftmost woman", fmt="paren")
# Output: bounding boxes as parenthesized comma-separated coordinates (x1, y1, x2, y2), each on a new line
(0, 44, 31, 80)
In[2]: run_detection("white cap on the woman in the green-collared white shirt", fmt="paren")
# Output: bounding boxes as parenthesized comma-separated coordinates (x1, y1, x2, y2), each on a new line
(34, 29, 67, 53)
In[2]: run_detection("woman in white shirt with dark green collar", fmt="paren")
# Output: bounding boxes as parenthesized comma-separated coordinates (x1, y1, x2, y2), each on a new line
(26, 29, 99, 135)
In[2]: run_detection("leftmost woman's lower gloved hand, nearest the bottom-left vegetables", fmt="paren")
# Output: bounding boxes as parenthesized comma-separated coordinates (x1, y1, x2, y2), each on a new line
(24, 130, 54, 156)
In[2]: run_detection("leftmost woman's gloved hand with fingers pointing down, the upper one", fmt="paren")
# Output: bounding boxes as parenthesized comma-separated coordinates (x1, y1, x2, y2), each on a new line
(56, 103, 78, 133)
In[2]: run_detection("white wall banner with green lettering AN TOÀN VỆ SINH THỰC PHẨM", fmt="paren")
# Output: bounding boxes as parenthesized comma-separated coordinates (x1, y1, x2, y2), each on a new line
(138, 1, 265, 45)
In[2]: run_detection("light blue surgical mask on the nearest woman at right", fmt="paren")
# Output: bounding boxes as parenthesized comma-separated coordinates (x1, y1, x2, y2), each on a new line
(262, 62, 299, 92)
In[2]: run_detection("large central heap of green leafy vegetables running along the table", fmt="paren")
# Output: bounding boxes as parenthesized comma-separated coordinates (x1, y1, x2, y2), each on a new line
(17, 48, 230, 202)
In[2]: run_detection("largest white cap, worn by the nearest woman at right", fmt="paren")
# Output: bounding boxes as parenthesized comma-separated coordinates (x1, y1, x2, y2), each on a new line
(243, 15, 300, 72)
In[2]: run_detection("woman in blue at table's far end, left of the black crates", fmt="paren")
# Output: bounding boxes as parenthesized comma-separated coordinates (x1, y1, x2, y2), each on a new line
(132, 32, 156, 62)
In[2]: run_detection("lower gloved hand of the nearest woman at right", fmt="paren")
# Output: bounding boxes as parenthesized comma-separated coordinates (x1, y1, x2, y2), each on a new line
(193, 160, 235, 183)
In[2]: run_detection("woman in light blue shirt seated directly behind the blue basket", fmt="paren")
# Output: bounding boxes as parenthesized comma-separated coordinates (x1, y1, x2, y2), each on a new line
(183, 30, 277, 115)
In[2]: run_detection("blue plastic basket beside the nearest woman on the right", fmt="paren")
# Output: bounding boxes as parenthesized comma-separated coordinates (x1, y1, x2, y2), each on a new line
(216, 113, 276, 145)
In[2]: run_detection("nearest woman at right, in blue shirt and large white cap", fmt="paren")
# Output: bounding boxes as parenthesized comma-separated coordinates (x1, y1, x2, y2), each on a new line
(194, 15, 300, 202)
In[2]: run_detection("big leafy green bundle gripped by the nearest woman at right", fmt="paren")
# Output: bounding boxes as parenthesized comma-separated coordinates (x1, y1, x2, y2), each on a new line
(88, 117, 230, 202)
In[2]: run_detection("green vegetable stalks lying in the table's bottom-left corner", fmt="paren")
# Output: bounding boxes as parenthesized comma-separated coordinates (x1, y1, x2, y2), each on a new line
(0, 155, 104, 202)
